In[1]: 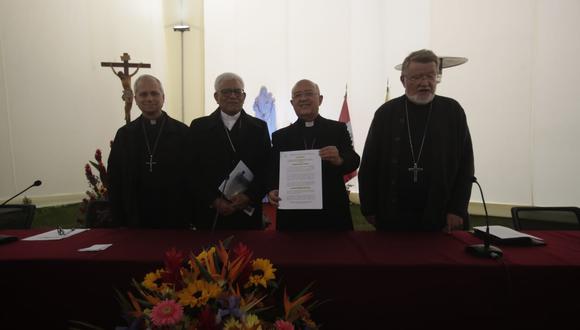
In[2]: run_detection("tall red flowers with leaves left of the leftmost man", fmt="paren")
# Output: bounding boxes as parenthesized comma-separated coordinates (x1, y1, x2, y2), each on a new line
(77, 149, 110, 223)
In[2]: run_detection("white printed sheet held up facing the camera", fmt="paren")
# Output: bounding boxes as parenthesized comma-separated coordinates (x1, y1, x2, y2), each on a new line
(278, 149, 322, 210)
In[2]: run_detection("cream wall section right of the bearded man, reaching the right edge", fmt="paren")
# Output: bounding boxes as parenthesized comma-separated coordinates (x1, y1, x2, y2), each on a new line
(431, 0, 580, 205)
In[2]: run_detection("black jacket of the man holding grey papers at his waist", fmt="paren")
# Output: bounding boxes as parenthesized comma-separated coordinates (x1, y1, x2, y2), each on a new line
(190, 108, 271, 229)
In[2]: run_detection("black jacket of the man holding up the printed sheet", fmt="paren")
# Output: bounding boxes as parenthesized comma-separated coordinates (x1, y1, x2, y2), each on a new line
(270, 115, 360, 230)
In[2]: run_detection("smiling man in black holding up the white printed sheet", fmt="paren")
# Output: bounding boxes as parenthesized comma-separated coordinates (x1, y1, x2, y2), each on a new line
(268, 80, 360, 230)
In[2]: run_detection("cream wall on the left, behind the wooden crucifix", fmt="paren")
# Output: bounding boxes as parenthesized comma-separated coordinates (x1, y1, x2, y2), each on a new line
(0, 0, 171, 202)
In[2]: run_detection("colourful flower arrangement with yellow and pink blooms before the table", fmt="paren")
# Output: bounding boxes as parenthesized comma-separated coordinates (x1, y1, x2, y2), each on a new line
(119, 237, 320, 330)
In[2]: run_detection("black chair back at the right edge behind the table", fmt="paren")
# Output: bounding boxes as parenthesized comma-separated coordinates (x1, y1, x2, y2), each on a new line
(511, 206, 580, 230)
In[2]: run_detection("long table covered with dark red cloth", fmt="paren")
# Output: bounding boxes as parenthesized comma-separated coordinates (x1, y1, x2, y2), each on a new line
(0, 229, 580, 329)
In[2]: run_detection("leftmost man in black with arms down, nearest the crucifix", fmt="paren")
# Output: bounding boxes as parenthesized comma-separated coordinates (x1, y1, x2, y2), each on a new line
(108, 75, 193, 228)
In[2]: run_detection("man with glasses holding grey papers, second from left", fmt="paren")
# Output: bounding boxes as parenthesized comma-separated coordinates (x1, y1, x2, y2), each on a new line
(190, 72, 271, 229)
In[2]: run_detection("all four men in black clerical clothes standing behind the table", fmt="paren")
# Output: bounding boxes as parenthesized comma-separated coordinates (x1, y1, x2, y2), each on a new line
(108, 50, 474, 231)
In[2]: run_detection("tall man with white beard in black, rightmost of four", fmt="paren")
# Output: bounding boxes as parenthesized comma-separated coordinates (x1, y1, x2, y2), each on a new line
(358, 50, 474, 231)
